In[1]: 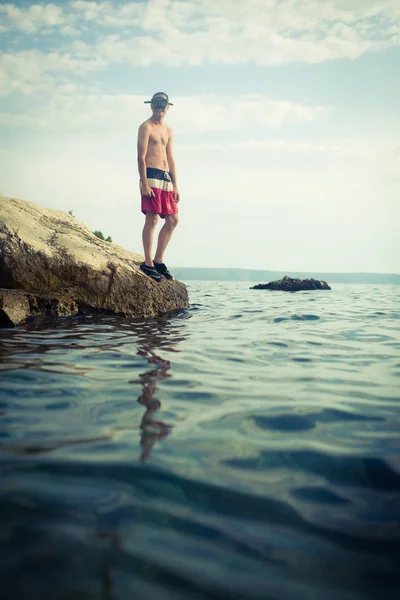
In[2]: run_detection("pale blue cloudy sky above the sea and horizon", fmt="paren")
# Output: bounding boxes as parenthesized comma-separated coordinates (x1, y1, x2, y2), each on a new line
(0, 0, 400, 274)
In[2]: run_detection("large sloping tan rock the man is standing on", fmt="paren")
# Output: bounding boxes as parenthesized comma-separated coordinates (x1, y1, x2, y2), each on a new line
(0, 196, 189, 327)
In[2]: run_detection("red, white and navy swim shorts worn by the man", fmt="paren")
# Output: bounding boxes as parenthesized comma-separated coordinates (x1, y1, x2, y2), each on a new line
(142, 167, 178, 219)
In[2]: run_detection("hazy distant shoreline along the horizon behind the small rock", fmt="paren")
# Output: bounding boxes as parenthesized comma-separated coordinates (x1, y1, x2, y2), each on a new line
(171, 267, 400, 285)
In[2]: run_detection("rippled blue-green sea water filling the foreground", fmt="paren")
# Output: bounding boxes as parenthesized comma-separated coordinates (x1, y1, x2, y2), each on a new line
(0, 282, 400, 600)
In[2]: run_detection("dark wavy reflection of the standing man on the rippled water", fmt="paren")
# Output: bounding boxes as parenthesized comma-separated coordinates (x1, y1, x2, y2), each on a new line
(138, 351, 172, 462)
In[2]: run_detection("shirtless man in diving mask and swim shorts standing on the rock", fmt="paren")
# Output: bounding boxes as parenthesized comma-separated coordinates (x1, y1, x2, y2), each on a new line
(138, 92, 179, 281)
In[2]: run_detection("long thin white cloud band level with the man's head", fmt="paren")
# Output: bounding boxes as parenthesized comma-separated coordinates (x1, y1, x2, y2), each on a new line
(0, 91, 329, 134)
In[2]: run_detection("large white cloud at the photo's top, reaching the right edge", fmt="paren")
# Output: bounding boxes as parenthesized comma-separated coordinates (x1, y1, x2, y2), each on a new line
(66, 0, 398, 66)
